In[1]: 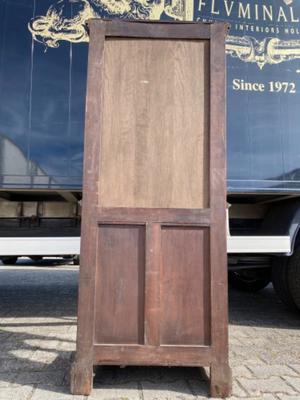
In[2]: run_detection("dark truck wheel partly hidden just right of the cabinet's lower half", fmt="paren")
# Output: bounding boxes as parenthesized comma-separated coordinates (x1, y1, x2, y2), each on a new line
(228, 269, 271, 293)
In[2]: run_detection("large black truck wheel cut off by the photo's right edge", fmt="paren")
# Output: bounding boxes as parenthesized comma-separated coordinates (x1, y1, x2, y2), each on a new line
(272, 247, 300, 310)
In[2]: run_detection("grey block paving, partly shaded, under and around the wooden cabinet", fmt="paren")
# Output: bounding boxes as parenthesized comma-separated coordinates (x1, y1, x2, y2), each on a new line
(0, 262, 300, 400)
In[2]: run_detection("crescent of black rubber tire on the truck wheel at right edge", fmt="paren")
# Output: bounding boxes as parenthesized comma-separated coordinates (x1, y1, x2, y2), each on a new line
(272, 256, 296, 309)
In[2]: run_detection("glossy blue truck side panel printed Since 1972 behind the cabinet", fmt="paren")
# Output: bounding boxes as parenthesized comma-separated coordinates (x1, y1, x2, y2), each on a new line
(0, 0, 300, 193)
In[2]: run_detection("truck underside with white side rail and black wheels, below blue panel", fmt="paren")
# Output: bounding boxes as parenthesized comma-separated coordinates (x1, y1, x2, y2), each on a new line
(0, 190, 300, 309)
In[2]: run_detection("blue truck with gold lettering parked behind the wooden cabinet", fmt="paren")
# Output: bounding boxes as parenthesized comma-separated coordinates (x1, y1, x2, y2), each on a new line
(0, 0, 300, 310)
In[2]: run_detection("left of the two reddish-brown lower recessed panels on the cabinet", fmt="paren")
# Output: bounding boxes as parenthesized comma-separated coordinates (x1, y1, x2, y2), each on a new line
(94, 224, 145, 344)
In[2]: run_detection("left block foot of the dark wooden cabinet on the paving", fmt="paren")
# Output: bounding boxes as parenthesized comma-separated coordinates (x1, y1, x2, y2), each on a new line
(71, 360, 93, 396)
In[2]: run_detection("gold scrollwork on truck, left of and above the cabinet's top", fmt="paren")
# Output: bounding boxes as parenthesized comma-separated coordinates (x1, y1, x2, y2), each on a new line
(28, 0, 193, 48)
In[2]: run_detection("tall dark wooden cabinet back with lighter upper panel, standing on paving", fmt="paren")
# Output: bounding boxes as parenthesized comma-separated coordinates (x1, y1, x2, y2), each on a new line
(71, 20, 231, 397)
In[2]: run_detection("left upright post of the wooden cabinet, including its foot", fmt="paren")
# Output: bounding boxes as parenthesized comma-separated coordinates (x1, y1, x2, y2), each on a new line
(71, 20, 105, 395)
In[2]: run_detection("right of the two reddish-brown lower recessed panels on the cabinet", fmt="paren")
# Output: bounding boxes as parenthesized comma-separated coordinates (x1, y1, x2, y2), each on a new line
(160, 226, 210, 345)
